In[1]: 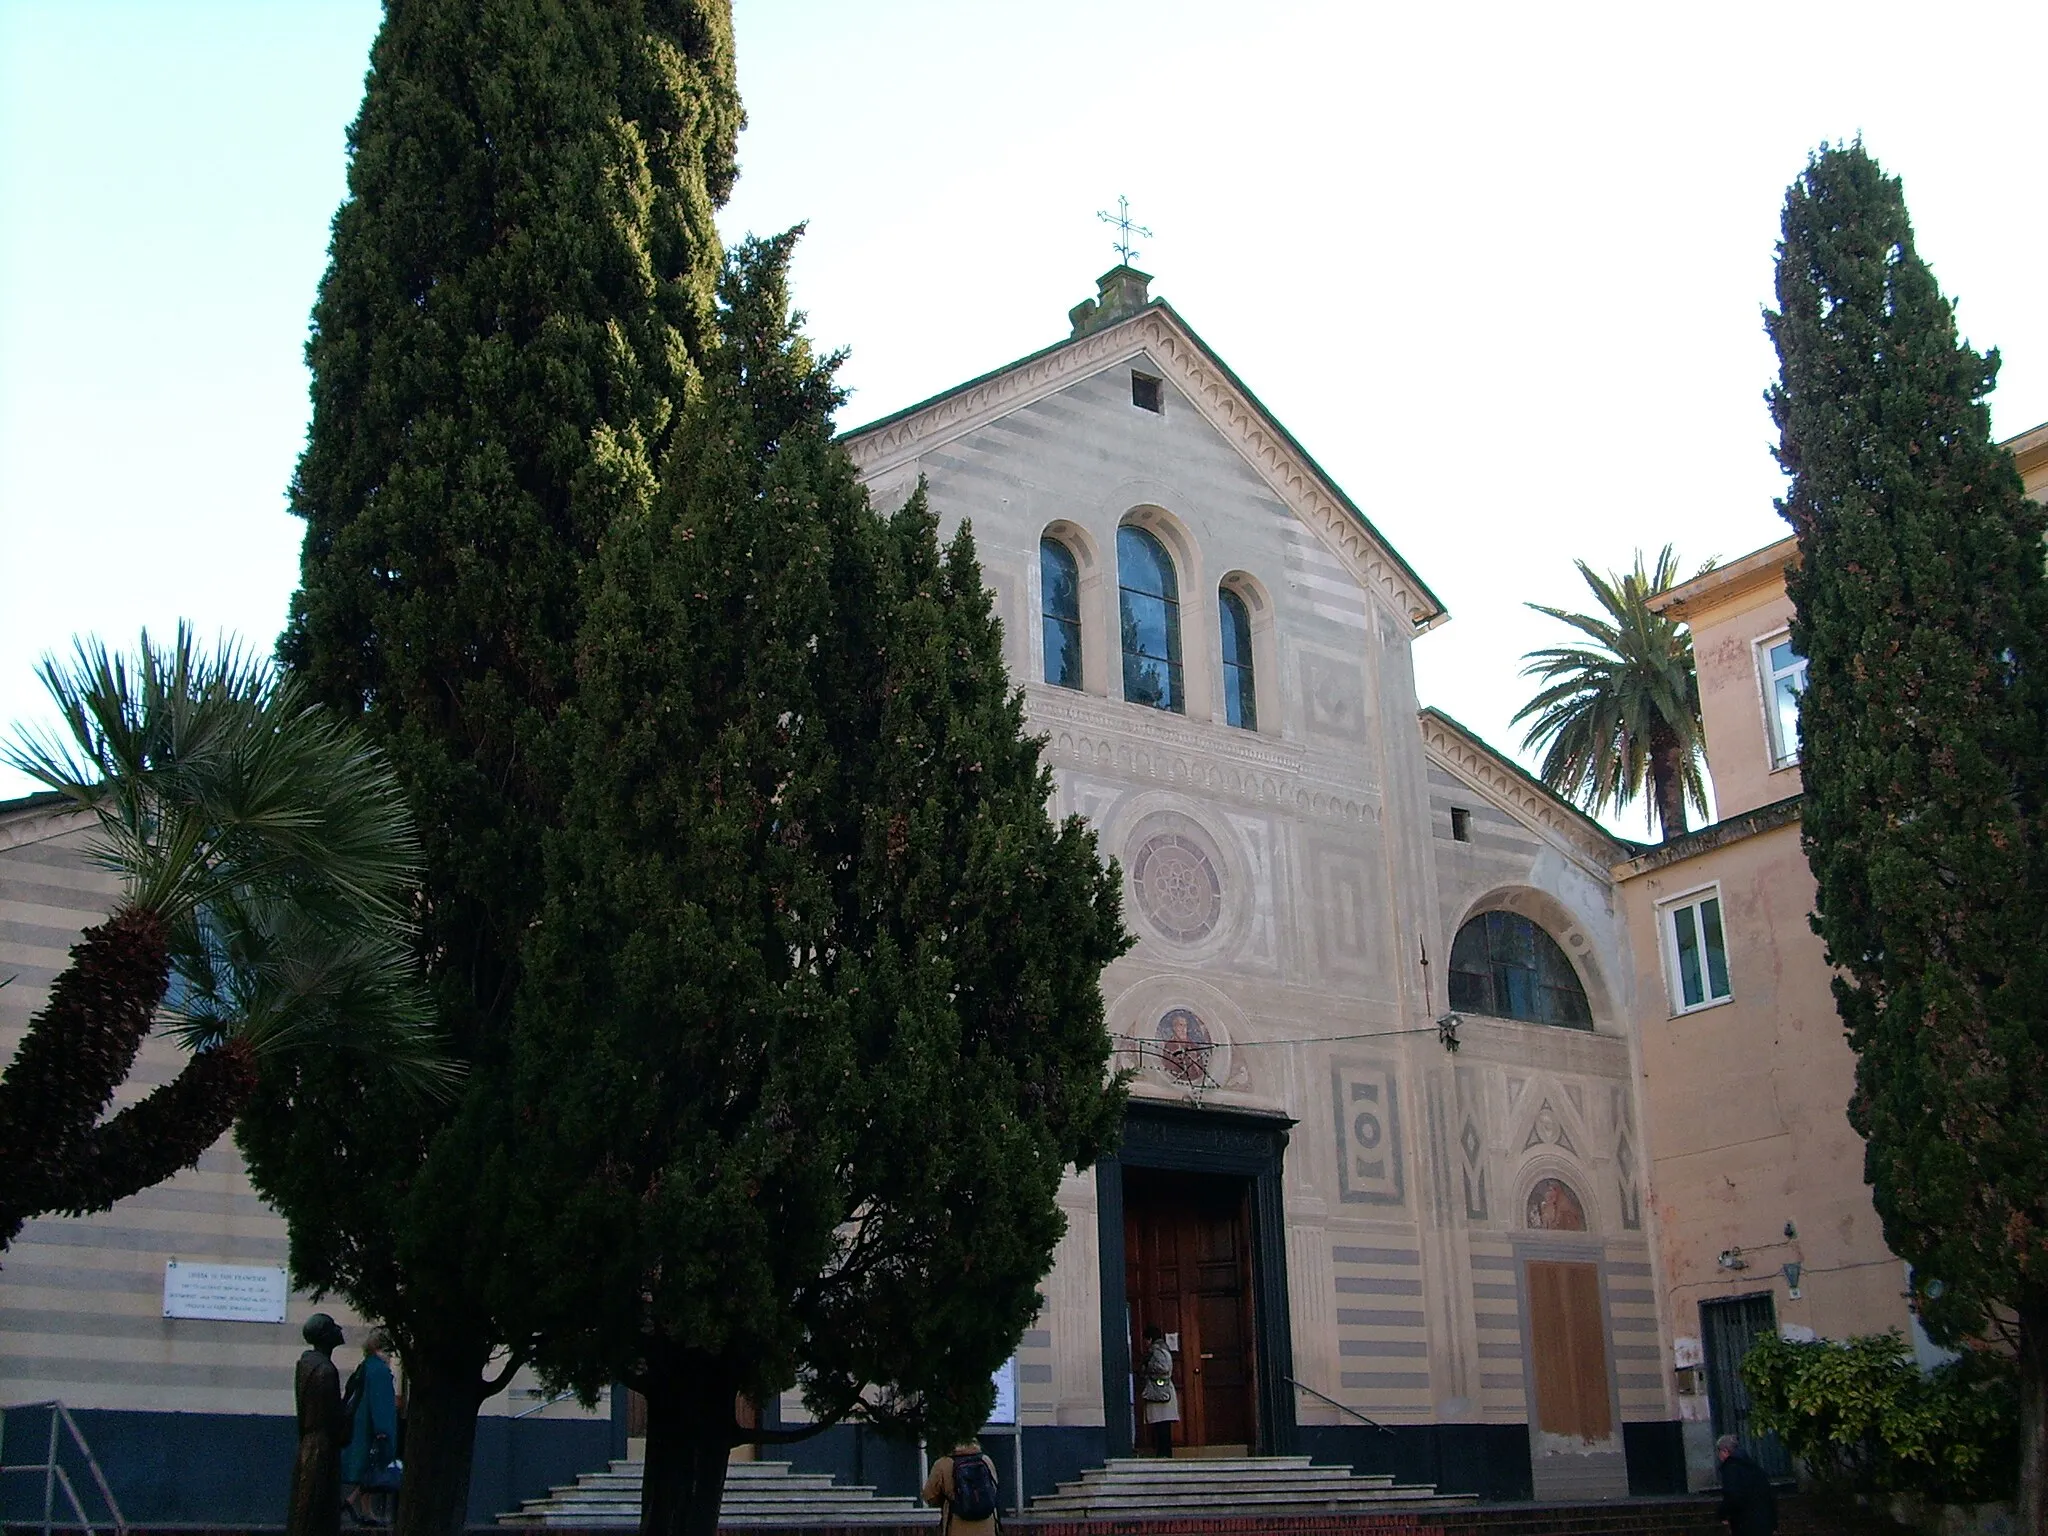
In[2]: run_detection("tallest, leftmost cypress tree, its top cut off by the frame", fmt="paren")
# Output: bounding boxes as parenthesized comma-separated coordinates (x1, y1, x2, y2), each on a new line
(242, 0, 741, 1536)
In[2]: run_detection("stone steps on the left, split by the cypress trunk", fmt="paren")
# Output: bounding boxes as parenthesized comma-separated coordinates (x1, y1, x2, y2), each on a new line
(498, 1460, 938, 1530)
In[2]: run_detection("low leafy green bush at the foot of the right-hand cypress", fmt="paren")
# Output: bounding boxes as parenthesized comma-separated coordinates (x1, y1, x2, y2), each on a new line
(1743, 1329, 2019, 1503)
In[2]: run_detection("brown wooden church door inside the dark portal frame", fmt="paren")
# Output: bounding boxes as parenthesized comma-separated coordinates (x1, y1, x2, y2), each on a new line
(1124, 1167, 1257, 1450)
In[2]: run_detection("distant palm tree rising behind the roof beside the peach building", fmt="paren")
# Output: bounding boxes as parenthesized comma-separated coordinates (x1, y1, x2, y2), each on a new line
(1516, 545, 1712, 842)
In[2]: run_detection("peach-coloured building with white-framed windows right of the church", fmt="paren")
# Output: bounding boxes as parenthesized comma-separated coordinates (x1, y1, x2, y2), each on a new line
(1614, 411, 2048, 1487)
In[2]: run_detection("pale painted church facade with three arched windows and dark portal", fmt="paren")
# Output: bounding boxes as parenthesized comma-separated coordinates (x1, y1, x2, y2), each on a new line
(815, 266, 1683, 1497)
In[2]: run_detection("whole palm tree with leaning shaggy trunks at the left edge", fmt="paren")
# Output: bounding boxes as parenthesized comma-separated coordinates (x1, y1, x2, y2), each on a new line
(0, 625, 453, 1249)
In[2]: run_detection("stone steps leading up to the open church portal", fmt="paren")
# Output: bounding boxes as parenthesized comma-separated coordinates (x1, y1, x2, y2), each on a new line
(1030, 1456, 1473, 1522)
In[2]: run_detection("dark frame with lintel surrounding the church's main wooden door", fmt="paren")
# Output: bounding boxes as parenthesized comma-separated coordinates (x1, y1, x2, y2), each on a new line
(1096, 1098, 1294, 1456)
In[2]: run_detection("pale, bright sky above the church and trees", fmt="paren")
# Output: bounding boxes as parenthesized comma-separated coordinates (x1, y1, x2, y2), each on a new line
(0, 0, 2048, 831)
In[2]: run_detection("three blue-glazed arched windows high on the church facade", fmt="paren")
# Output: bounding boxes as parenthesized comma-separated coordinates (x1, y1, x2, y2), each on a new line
(1038, 522, 1260, 731)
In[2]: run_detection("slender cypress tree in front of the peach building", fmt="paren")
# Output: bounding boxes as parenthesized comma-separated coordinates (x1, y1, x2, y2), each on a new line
(1767, 143, 2048, 1532)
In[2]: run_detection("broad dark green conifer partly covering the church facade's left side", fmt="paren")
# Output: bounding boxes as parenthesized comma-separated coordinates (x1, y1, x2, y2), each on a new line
(498, 236, 1128, 1536)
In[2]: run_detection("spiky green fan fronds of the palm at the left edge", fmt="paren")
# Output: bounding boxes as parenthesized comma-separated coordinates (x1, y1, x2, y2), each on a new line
(4, 625, 457, 1094)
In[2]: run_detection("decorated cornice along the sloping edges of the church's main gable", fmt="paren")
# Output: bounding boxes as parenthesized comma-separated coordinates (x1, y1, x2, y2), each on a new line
(840, 299, 1448, 631)
